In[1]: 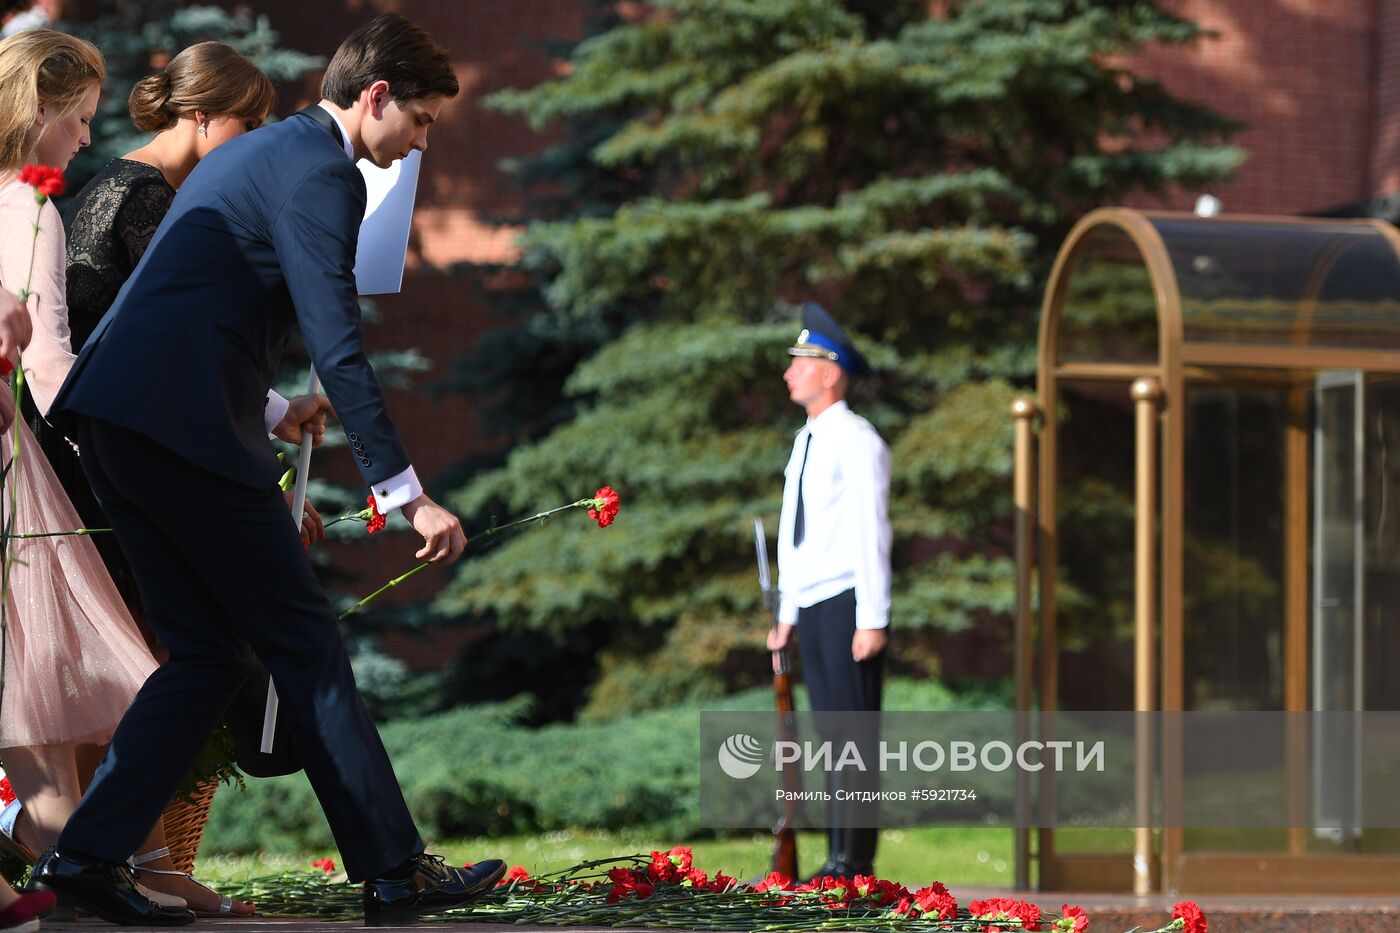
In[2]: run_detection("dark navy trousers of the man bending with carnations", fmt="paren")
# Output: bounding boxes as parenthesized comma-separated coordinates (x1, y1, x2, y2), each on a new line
(59, 419, 423, 880)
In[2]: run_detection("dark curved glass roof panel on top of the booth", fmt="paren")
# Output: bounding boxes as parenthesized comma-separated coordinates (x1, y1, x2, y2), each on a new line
(1151, 217, 1400, 350)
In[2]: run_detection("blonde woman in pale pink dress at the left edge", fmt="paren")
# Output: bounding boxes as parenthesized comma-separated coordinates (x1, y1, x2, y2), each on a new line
(0, 29, 251, 923)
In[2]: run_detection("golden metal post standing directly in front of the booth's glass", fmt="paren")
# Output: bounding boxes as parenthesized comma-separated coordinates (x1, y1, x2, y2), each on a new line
(1133, 378, 1162, 894)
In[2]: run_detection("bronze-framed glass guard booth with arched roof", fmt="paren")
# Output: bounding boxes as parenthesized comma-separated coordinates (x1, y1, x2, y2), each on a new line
(1015, 209, 1400, 894)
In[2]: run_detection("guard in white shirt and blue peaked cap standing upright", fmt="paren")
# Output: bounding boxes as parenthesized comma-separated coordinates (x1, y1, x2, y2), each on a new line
(769, 301, 892, 877)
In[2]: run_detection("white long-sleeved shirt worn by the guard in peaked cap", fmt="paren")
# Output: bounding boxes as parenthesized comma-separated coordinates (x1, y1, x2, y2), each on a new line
(778, 401, 892, 629)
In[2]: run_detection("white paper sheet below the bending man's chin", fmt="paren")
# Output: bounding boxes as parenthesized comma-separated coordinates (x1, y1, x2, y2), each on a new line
(354, 150, 423, 294)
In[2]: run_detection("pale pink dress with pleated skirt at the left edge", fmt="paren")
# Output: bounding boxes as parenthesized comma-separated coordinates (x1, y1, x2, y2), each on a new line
(0, 172, 155, 748)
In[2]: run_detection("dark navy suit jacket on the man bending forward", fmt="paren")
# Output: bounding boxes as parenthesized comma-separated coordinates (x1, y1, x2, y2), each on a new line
(52, 108, 409, 486)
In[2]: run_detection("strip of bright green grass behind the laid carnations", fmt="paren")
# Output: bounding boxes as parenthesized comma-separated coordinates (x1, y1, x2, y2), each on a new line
(196, 828, 1015, 894)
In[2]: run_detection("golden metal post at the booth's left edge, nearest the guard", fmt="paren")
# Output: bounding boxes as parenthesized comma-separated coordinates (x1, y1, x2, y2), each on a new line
(1011, 396, 1040, 891)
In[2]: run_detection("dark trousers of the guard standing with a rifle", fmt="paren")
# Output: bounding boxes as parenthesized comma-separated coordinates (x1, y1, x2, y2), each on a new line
(797, 590, 885, 871)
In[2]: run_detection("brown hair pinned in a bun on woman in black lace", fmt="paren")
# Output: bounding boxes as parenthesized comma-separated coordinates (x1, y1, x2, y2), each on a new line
(127, 42, 277, 133)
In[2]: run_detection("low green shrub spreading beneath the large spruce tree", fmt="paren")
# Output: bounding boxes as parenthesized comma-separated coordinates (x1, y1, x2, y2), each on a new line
(203, 681, 1005, 853)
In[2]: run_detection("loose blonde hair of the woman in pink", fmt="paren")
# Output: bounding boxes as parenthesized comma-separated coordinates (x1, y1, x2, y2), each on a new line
(0, 29, 106, 171)
